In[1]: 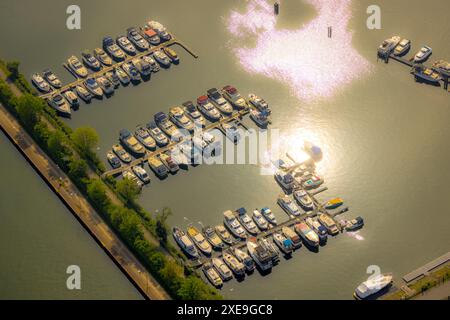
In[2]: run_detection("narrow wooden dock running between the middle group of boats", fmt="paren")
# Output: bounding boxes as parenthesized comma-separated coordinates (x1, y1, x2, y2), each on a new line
(102, 109, 249, 177)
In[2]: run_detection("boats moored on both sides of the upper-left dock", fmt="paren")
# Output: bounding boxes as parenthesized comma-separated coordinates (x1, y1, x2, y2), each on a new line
(31, 21, 179, 116)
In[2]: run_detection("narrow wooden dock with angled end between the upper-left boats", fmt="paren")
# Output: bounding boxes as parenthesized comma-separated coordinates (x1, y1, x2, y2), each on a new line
(40, 33, 198, 99)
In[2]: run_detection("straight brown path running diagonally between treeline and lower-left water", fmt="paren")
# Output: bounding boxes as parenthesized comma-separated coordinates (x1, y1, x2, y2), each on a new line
(0, 71, 170, 300)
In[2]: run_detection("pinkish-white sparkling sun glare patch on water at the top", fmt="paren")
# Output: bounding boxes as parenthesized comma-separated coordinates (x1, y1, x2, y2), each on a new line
(226, 0, 373, 100)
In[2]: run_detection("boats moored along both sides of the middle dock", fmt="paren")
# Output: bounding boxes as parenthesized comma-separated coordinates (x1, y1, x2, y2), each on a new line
(107, 89, 270, 178)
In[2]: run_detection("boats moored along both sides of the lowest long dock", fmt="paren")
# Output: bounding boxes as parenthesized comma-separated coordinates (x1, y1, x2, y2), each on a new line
(173, 207, 364, 287)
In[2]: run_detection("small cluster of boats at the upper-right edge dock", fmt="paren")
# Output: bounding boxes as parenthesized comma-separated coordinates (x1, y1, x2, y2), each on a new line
(378, 36, 450, 84)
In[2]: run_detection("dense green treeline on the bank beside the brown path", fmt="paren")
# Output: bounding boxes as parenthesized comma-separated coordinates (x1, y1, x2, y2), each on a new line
(0, 60, 221, 300)
